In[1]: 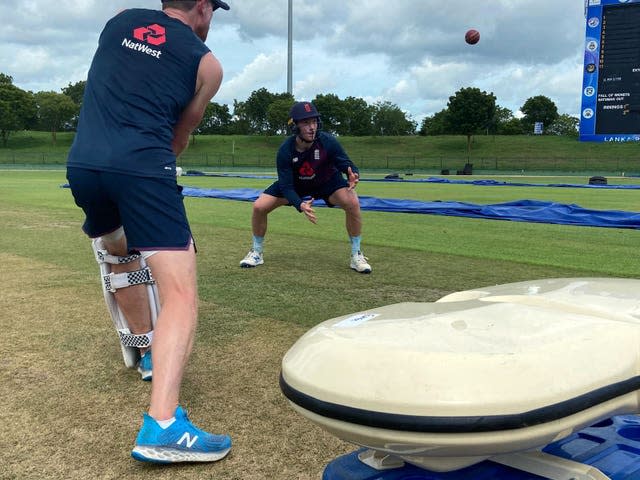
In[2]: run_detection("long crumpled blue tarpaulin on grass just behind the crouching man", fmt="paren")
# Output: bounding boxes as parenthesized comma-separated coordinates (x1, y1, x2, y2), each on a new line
(182, 187, 640, 229)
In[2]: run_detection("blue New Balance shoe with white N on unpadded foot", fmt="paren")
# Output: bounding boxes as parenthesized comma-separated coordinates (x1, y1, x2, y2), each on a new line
(131, 407, 231, 463)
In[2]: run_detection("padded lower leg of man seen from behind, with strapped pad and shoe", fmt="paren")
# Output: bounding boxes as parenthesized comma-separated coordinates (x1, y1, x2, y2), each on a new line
(91, 227, 160, 381)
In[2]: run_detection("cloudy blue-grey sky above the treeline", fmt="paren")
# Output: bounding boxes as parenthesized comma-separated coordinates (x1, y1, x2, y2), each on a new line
(0, 0, 585, 121)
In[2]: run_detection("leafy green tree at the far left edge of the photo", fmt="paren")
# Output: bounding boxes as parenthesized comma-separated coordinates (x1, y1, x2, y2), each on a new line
(0, 74, 36, 147)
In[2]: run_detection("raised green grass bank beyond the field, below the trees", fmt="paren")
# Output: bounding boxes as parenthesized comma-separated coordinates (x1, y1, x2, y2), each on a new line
(0, 132, 640, 175)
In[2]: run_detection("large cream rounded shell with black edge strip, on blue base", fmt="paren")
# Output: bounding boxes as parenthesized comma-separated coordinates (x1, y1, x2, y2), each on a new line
(280, 278, 640, 471)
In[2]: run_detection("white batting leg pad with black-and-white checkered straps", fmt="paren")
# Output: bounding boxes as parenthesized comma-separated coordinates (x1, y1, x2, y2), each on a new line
(92, 238, 160, 368)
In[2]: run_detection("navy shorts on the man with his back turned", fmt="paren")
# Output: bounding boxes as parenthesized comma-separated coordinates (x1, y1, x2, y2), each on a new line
(67, 167, 192, 250)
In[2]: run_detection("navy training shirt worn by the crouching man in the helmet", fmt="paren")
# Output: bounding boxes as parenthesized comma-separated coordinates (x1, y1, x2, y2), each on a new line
(276, 131, 358, 210)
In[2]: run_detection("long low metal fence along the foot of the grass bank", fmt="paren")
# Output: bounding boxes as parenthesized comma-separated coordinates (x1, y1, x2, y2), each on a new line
(0, 150, 640, 175)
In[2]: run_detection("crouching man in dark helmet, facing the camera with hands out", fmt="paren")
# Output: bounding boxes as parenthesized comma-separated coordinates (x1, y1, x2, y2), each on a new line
(240, 102, 371, 273)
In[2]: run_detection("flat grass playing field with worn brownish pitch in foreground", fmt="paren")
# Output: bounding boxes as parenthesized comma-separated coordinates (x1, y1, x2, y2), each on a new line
(0, 169, 640, 480)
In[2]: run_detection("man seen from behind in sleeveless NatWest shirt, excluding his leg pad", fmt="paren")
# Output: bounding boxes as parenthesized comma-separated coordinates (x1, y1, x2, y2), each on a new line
(67, 0, 231, 463)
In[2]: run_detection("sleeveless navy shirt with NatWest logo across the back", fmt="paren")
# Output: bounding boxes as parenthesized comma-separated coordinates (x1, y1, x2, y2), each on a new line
(67, 9, 210, 177)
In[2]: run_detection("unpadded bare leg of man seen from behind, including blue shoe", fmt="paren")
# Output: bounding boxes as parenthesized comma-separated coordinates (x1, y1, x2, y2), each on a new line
(131, 244, 231, 463)
